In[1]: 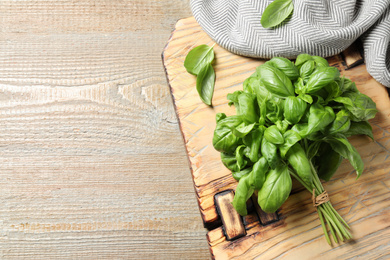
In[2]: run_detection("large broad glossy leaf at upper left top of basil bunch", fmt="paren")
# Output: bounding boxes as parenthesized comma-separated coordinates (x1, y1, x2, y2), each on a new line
(257, 64, 295, 98)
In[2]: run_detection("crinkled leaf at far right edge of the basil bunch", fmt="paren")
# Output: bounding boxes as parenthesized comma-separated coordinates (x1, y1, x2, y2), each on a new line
(343, 92, 378, 121)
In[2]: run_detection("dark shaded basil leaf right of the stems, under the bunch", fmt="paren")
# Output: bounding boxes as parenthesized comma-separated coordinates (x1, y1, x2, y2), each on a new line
(316, 142, 343, 181)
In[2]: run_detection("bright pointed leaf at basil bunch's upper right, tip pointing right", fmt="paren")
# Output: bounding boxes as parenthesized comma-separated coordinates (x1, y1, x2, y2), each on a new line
(306, 67, 340, 94)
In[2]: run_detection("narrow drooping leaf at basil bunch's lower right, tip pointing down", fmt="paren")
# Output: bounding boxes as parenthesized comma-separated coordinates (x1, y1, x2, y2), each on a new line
(326, 135, 364, 179)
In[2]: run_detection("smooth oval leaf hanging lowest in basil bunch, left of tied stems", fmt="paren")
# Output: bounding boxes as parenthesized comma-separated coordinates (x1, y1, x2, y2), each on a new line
(258, 164, 292, 213)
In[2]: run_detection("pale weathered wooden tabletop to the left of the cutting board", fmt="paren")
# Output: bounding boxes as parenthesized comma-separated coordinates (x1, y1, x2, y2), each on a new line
(0, 0, 210, 259)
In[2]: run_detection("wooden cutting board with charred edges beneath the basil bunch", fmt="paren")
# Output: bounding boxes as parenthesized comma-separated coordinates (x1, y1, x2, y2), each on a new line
(163, 17, 390, 260)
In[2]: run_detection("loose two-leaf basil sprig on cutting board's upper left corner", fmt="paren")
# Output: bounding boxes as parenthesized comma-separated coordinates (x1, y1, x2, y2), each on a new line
(184, 44, 215, 106)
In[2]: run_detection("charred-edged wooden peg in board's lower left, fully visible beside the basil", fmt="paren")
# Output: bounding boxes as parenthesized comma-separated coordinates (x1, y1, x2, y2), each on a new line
(214, 190, 246, 241)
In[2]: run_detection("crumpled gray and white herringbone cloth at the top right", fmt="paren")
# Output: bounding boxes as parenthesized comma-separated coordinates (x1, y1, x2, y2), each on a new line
(191, 0, 390, 87)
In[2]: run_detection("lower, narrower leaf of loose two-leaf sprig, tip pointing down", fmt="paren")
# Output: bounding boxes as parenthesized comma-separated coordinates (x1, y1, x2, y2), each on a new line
(196, 63, 215, 106)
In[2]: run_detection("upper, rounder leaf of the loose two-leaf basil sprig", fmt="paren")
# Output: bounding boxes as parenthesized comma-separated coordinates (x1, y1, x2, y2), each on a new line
(184, 44, 214, 75)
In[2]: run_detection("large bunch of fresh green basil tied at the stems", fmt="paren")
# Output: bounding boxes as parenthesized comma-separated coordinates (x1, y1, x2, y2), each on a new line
(213, 54, 377, 243)
